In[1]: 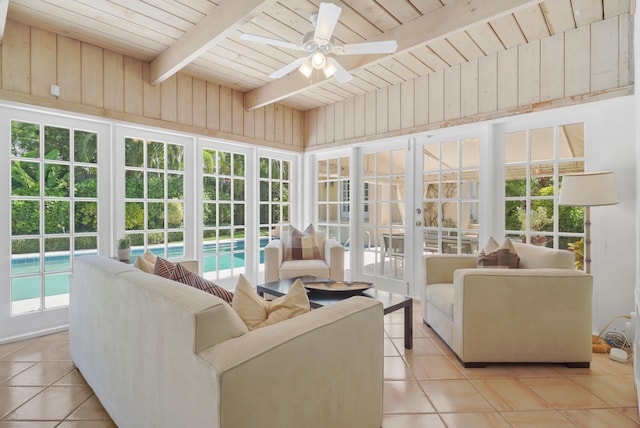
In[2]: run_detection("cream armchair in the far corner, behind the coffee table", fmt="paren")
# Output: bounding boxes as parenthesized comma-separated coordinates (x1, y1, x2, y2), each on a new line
(264, 232, 344, 282)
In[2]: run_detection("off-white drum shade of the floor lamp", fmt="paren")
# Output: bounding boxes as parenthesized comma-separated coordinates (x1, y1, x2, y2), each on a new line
(558, 171, 618, 207)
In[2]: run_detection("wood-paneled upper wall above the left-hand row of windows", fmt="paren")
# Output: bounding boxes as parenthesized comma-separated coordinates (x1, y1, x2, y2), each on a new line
(0, 20, 304, 151)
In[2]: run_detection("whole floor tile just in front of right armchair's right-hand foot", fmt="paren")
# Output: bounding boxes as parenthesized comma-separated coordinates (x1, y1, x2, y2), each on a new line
(522, 377, 609, 409)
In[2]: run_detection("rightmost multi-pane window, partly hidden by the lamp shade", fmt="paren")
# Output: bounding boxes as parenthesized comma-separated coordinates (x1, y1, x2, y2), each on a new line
(504, 123, 584, 251)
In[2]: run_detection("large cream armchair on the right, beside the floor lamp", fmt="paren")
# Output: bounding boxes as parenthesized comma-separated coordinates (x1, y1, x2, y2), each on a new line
(421, 243, 593, 367)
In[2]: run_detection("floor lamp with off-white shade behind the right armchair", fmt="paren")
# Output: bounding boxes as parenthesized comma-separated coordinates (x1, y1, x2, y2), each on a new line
(558, 171, 618, 273)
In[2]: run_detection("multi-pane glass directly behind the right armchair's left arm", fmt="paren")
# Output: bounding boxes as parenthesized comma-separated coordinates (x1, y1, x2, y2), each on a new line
(422, 138, 480, 254)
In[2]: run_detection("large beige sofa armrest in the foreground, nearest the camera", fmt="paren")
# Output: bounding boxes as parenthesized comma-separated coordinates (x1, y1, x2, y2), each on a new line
(198, 296, 384, 428)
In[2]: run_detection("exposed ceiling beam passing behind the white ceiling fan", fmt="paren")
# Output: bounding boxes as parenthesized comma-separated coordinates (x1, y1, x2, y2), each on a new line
(244, 0, 541, 110)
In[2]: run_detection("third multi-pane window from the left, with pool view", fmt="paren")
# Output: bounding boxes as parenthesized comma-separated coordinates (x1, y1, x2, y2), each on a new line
(202, 148, 246, 279)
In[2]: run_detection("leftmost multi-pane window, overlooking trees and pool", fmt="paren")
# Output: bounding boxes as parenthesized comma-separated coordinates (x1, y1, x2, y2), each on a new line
(10, 120, 98, 315)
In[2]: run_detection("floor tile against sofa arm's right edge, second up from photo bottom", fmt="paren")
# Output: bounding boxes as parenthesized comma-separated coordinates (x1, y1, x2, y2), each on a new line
(383, 380, 436, 414)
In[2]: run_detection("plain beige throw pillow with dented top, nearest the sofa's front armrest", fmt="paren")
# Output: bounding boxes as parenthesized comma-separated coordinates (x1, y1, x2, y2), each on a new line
(231, 275, 311, 330)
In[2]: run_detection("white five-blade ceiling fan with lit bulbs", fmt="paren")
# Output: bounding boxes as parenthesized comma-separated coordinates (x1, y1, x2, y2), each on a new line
(240, 3, 398, 83)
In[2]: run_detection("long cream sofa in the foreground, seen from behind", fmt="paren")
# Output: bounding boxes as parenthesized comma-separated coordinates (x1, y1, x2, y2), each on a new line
(70, 256, 383, 428)
